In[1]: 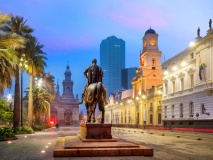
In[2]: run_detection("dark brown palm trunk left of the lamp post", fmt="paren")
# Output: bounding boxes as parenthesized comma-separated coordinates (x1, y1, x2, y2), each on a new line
(13, 65, 21, 130)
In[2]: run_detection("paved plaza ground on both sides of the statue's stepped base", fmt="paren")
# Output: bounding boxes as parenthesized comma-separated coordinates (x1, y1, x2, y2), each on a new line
(0, 127, 213, 160)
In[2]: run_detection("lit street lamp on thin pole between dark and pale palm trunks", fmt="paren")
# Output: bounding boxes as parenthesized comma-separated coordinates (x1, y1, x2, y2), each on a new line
(19, 54, 28, 126)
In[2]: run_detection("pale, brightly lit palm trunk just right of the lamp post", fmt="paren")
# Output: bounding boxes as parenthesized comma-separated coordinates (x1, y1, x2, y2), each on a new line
(28, 75, 33, 127)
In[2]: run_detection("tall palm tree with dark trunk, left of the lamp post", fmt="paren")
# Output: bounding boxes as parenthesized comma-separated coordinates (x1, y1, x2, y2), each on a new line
(2, 16, 33, 130)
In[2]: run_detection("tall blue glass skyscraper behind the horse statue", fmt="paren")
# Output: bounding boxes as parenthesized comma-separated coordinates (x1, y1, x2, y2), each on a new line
(100, 36, 125, 99)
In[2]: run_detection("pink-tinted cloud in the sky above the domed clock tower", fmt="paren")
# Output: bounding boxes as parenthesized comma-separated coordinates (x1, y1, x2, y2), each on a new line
(107, 3, 172, 30)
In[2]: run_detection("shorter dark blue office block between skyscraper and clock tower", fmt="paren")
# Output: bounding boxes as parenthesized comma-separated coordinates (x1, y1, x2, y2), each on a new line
(121, 67, 137, 89)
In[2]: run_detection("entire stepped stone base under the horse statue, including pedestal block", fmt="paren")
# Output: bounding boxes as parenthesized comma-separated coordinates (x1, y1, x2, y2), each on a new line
(53, 123, 154, 157)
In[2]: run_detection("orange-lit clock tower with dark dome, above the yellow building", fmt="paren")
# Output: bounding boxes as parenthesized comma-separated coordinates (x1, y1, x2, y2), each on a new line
(132, 28, 162, 97)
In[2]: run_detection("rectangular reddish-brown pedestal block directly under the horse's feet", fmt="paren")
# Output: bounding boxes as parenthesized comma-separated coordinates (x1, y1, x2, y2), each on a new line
(80, 123, 112, 139)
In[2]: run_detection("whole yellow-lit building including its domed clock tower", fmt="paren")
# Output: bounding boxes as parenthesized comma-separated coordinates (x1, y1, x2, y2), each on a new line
(105, 28, 162, 128)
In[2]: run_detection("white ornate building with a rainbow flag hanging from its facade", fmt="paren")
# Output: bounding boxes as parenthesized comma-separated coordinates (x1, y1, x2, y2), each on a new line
(162, 28, 213, 128)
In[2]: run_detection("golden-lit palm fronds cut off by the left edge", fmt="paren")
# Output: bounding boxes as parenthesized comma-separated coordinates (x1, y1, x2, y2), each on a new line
(0, 12, 25, 93)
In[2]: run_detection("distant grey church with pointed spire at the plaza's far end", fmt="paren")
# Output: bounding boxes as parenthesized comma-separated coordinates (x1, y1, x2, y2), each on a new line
(50, 65, 79, 125)
